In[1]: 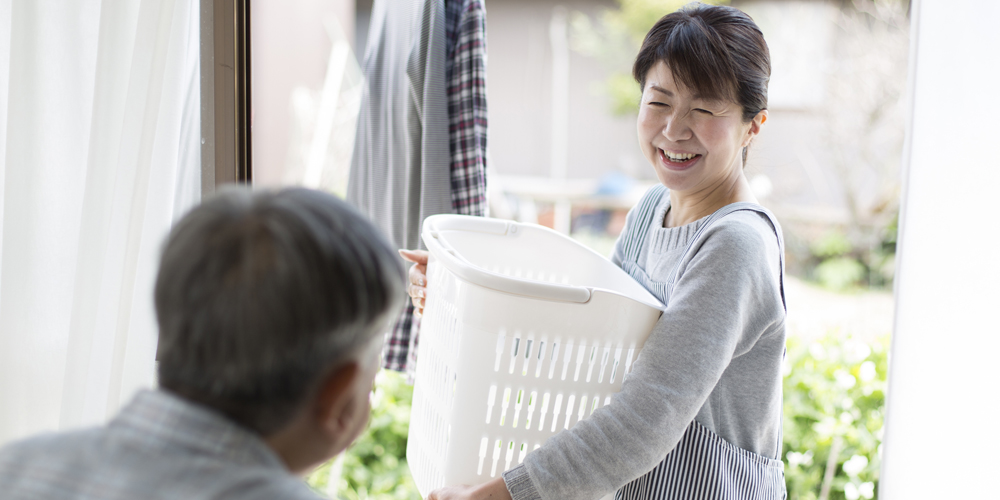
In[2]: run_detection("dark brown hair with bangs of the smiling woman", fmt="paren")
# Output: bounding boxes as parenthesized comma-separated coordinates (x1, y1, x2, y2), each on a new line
(632, 2, 771, 122)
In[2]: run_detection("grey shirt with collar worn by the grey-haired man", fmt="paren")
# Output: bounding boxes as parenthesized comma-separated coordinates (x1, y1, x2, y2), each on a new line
(0, 391, 318, 500)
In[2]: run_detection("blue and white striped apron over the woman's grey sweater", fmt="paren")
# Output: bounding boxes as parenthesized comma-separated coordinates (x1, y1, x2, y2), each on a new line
(615, 186, 786, 500)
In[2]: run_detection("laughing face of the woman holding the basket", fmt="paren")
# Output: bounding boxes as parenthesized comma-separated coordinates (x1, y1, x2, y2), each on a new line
(637, 61, 766, 195)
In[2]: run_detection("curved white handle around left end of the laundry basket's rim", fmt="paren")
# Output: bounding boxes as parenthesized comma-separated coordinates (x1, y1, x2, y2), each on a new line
(423, 215, 592, 303)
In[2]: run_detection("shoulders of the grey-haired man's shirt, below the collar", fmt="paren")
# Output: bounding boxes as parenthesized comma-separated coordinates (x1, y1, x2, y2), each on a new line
(0, 427, 319, 500)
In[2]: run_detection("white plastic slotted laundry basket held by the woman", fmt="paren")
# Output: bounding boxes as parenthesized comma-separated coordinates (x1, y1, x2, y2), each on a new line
(406, 215, 662, 496)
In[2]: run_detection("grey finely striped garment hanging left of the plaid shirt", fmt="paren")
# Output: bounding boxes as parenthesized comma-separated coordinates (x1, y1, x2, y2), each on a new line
(347, 0, 452, 252)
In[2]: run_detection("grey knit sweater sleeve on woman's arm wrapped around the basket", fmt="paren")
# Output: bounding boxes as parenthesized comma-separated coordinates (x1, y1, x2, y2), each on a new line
(504, 219, 780, 500)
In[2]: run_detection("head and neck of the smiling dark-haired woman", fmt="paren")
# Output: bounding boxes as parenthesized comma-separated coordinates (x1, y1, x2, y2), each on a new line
(632, 4, 771, 227)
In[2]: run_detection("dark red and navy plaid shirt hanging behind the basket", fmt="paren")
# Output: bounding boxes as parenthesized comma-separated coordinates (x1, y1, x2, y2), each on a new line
(383, 0, 487, 375)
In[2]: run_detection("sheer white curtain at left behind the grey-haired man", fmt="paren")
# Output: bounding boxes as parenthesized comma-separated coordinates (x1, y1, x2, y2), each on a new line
(0, 0, 200, 444)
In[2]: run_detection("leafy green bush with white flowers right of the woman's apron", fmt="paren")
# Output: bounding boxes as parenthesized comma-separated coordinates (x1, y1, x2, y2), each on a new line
(783, 335, 889, 500)
